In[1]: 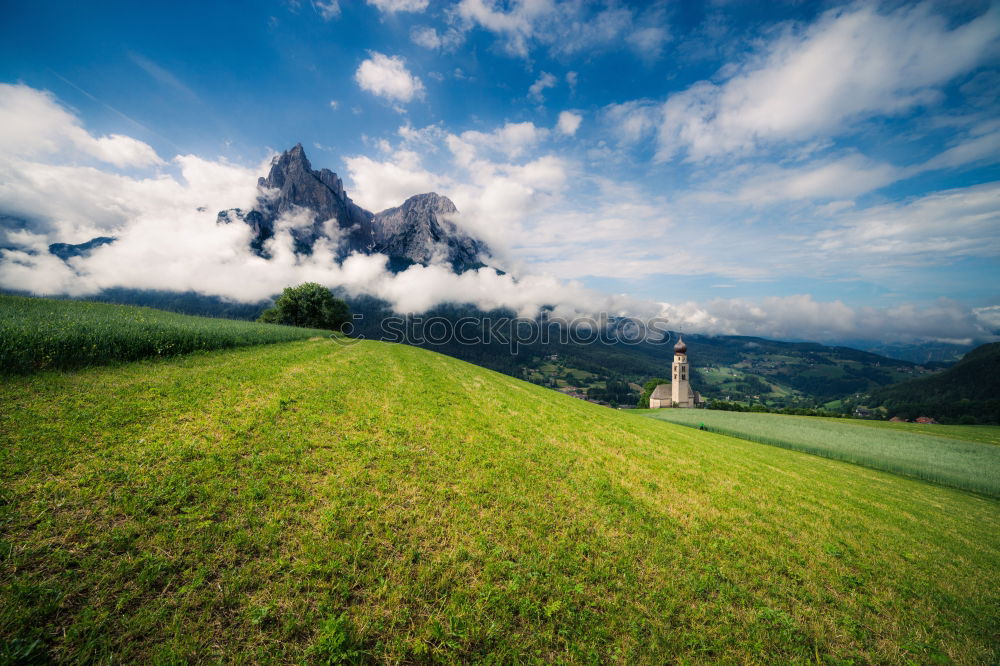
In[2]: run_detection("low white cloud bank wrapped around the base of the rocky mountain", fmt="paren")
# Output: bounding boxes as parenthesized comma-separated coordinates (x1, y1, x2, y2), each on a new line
(0, 85, 1000, 341)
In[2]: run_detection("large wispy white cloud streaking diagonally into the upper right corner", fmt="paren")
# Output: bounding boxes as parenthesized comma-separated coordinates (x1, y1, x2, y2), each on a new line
(658, 4, 1000, 160)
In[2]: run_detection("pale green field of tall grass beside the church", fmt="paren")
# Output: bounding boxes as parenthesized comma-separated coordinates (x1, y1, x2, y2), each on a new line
(633, 409, 1000, 498)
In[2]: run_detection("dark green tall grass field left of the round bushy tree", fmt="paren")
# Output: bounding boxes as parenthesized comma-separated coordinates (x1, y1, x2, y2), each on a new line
(0, 294, 331, 373)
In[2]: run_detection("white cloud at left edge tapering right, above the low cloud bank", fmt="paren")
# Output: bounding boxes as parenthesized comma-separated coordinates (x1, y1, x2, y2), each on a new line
(0, 83, 163, 167)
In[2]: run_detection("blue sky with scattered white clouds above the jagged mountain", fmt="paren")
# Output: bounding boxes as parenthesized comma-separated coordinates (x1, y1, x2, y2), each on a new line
(0, 0, 1000, 339)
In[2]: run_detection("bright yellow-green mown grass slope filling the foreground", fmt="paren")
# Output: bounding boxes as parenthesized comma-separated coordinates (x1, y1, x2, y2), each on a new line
(0, 340, 1000, 664)
